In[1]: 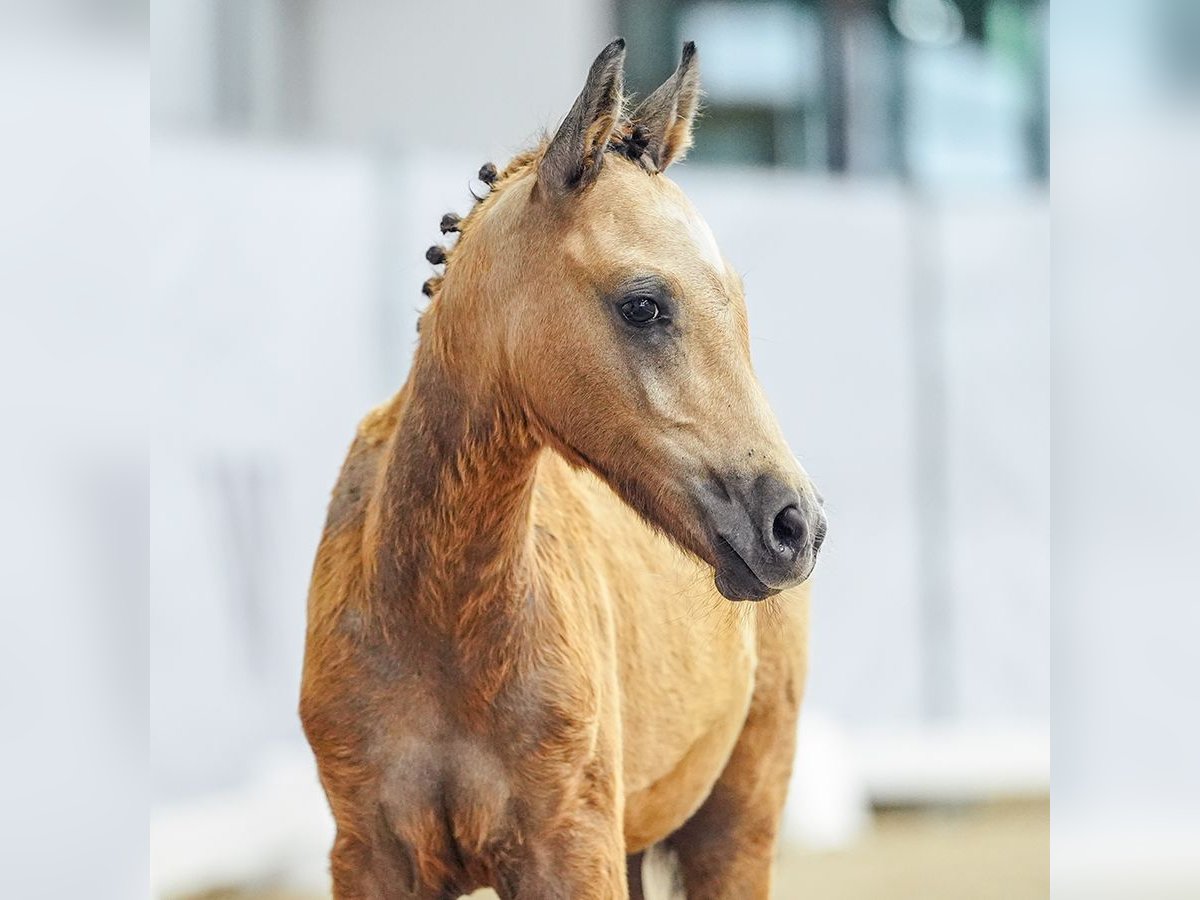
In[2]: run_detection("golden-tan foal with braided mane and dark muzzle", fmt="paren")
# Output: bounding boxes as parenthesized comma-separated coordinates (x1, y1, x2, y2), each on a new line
(300, 38, 826, 900)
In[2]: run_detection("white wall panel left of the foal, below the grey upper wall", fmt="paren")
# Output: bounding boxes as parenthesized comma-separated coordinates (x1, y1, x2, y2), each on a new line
(150, 142, 380, 798)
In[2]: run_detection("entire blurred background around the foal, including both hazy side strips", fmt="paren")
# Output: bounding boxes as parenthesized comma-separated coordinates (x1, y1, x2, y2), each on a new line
(0, 0, 1200, 900)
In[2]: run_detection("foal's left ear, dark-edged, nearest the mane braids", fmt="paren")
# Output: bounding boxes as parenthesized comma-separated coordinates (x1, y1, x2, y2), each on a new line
(538, 37, 625, 197)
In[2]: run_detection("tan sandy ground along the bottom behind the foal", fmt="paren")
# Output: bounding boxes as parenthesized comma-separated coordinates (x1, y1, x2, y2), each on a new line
(180, 799, 1050, 900)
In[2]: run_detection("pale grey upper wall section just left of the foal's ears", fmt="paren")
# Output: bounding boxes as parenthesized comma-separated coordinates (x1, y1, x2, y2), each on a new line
(310, 0, 614, 154)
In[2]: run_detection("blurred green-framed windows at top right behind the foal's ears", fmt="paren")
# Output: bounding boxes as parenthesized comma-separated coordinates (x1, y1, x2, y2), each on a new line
(617, 0, 1048, 184)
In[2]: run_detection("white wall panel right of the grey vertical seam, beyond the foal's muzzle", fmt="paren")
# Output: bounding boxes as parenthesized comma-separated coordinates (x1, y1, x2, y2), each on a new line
(937, 194, 1051, 725)
